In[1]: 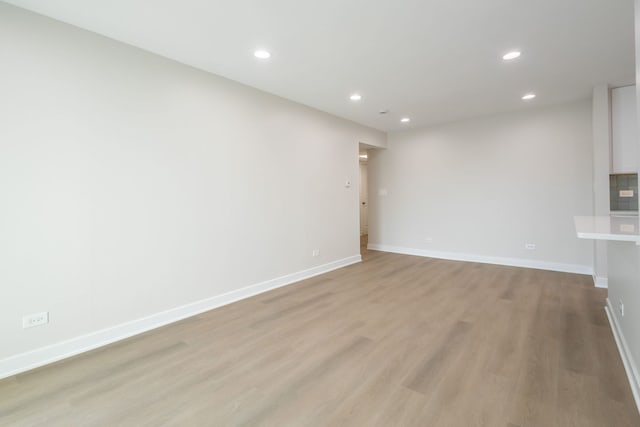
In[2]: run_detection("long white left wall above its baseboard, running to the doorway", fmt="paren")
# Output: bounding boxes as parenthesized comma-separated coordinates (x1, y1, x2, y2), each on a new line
(0, 3, 385, 373)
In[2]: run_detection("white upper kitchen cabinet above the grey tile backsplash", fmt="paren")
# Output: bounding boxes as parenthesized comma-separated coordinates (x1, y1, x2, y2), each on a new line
(611, 86, 638, 173)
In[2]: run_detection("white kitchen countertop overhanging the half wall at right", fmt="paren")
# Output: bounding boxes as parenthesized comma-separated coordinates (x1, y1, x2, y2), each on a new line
(573, 215, 640, 245)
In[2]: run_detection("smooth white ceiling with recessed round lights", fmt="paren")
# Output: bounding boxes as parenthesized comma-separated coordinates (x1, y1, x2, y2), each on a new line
(7, 0, 635, 131)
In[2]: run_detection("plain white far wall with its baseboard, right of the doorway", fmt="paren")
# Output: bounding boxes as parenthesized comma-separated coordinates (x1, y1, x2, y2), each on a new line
(369, 101, 593, 273)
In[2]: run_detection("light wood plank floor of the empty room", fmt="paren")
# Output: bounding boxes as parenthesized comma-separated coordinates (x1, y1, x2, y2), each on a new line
(0, 247, 640, 427)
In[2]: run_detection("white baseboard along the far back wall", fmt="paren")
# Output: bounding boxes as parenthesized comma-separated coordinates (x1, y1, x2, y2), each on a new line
(367, 243, 593, 275)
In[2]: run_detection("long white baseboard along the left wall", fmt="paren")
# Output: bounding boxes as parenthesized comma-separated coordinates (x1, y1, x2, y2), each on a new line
(0, 255, 362, 379)
